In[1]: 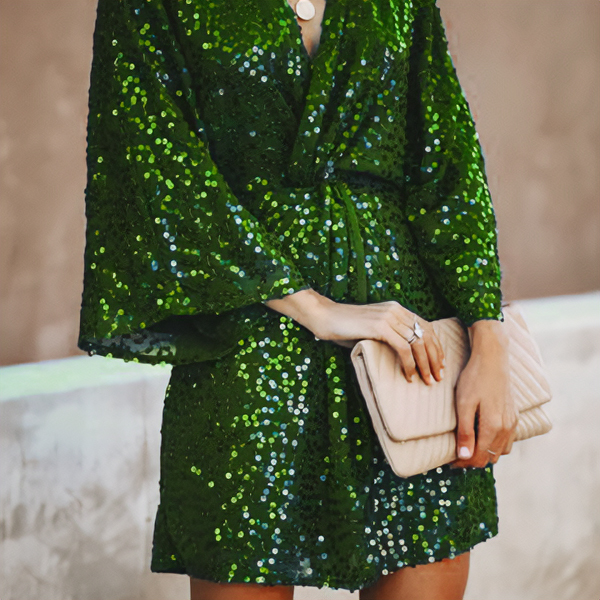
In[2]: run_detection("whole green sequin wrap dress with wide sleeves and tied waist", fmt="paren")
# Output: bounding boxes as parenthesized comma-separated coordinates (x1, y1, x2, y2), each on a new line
(78, 0, 502, 590)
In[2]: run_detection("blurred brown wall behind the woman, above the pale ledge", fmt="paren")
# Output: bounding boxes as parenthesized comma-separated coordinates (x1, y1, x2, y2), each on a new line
(0, 0, 600, 365)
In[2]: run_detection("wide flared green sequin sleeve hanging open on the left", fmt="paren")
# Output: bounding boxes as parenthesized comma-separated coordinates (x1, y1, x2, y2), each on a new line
(78, 0, 310, 363)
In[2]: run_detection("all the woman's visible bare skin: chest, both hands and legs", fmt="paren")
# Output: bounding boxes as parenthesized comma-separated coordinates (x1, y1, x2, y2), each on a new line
(190, 0, 517, 600)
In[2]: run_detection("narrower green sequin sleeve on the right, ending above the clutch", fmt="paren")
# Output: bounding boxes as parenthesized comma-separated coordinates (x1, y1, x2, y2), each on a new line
(405, 1, 503, 325)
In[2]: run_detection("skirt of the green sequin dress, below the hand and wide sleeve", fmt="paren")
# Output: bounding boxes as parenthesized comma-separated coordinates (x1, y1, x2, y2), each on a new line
(151, 311, 498, 591)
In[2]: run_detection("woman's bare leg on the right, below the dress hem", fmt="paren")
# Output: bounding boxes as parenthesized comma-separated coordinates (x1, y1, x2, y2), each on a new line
(359, 552, 470, 600)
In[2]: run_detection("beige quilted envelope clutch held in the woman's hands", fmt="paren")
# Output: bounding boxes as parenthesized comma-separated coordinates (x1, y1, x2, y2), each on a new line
(351, 304, 552, 477)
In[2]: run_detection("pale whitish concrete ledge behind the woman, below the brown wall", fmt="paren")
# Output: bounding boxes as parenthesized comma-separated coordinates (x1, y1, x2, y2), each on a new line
(0, 292, 600, 600)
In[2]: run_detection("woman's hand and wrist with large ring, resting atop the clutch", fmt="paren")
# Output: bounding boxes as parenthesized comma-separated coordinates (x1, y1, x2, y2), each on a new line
(265, 289, 444, 385)
